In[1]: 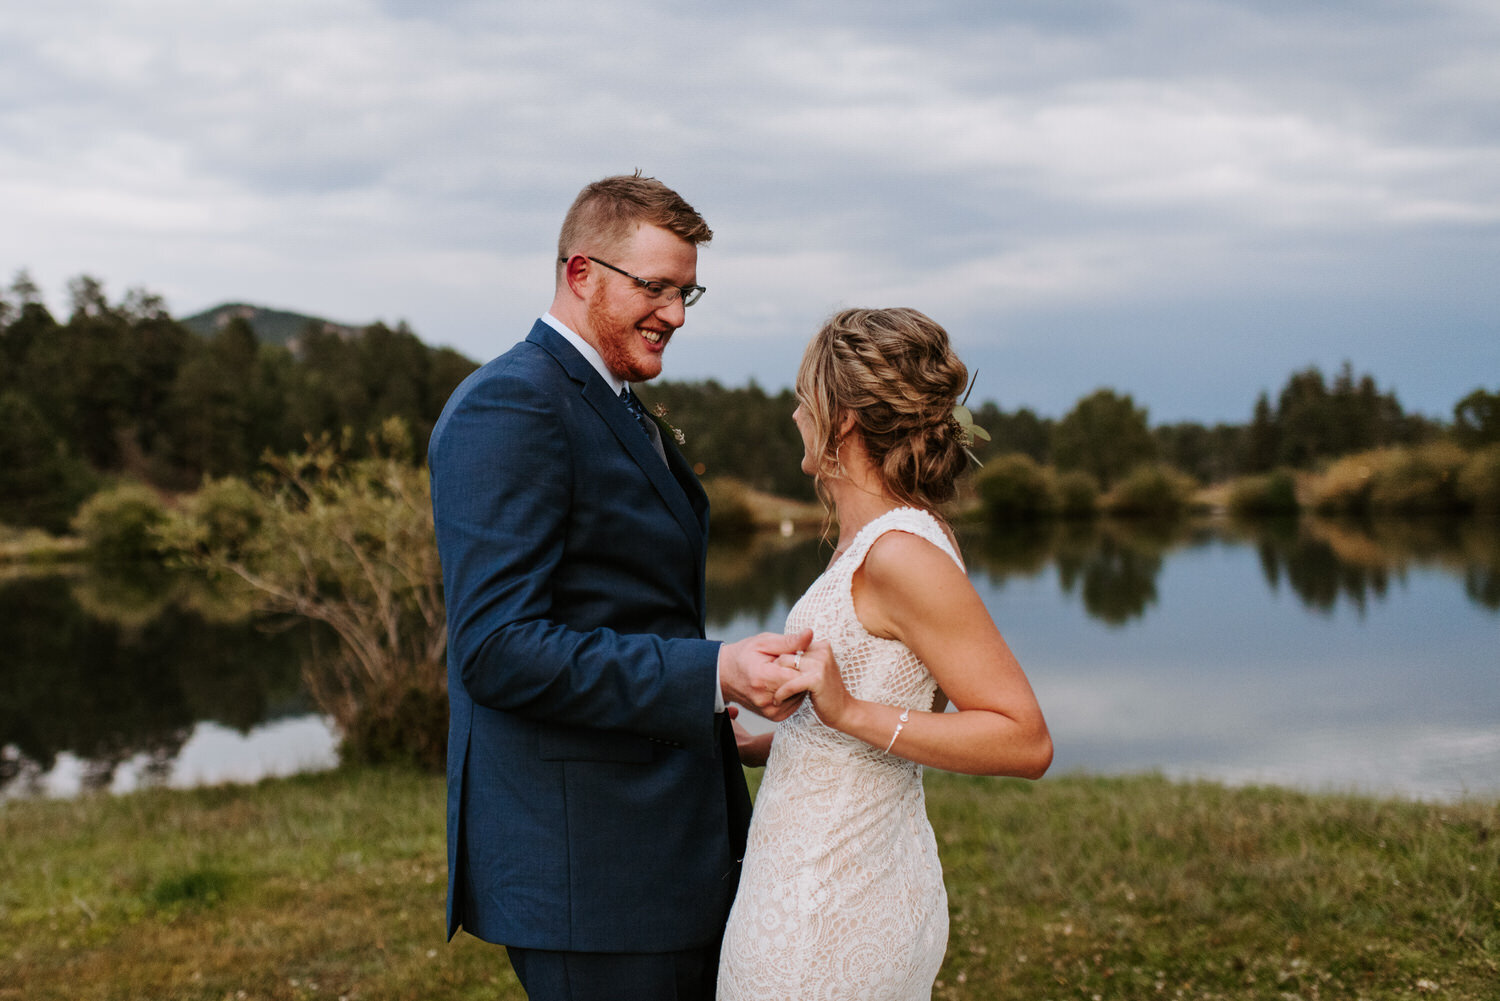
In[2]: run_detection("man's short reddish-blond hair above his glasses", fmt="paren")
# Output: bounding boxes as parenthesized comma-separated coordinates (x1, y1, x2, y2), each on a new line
(557, 171, 714, 281)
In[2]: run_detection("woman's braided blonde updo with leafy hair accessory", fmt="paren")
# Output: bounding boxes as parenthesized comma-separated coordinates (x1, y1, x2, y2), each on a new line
(797, 308, 969, 509)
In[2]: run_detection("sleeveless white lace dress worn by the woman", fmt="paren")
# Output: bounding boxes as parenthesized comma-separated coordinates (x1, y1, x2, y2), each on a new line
(719, 507, 963, 1001)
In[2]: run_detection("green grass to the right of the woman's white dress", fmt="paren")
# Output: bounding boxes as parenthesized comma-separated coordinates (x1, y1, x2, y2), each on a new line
(929, 776, 1500, 999)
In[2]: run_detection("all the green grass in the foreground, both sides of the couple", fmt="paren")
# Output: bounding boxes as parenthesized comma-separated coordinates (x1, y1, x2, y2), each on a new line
(0, 770, 1500, 1001)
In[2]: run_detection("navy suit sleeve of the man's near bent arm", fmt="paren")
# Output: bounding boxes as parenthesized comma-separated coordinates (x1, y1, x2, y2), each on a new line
(429, 355, 719, 744)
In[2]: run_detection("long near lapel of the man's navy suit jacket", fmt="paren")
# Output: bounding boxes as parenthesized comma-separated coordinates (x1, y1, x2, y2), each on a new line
(527, 320, 708, 555)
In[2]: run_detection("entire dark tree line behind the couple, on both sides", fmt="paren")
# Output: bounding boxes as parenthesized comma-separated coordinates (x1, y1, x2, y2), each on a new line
(0, 264, 1500, 531)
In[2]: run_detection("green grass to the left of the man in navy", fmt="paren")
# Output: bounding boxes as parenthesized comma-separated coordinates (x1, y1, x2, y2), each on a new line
(0, 770, 504, 1001)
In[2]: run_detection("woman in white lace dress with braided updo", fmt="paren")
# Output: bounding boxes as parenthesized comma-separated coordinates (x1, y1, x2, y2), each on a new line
(719, 309, 1052, 1001)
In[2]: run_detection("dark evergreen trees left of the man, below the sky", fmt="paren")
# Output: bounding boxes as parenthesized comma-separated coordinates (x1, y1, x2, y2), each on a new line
(0, 273, 474, 531)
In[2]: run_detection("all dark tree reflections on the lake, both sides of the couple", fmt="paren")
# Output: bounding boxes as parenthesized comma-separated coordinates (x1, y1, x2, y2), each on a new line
(0, 518, 1500, 795)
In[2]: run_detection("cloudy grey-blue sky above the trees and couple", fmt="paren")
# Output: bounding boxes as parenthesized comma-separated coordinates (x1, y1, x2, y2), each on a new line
(0, 0, 1500, 422)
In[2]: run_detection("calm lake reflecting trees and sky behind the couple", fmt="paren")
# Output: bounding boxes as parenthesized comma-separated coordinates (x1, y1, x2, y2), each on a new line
(0, 519, 1500, 800)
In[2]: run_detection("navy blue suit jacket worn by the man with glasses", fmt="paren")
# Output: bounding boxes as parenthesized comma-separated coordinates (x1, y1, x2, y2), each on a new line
(429, 321, 750, 951)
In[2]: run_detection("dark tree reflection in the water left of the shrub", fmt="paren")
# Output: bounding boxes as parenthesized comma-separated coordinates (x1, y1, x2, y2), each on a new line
(0, 572, 309, 789)
